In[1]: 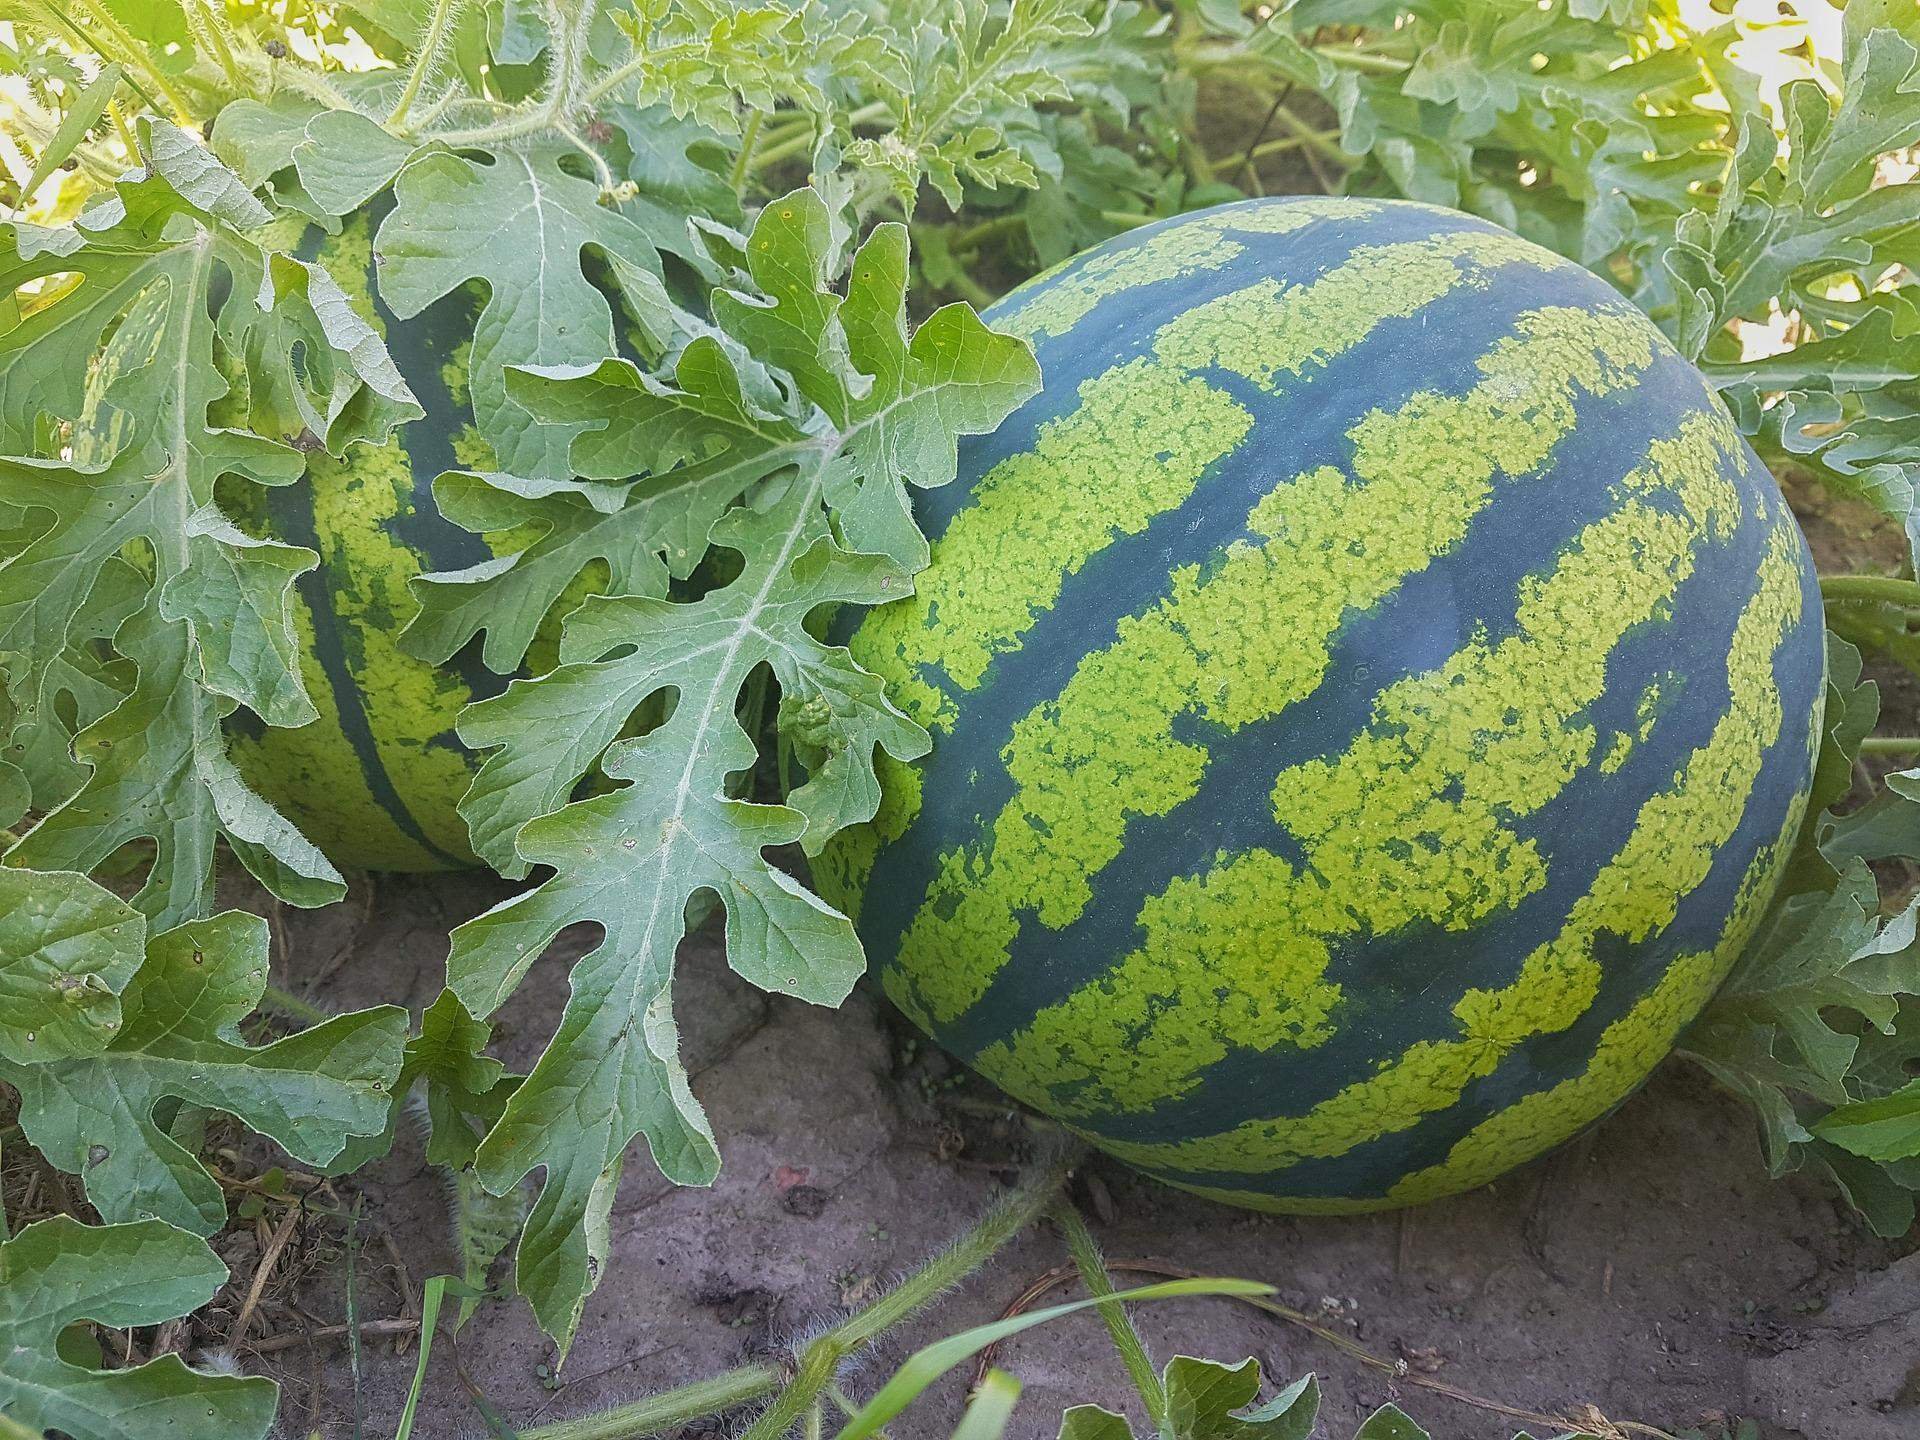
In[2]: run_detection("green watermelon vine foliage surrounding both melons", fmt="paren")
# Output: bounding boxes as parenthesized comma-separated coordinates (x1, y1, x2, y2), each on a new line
(0, 0, 1920, 1434)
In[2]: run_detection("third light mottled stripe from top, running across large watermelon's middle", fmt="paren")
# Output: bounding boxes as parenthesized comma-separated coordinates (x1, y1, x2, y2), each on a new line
(887, 305, 1657, 1023)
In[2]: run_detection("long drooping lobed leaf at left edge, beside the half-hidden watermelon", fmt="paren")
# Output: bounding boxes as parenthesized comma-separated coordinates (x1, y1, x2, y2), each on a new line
(0, 117, 419, 927)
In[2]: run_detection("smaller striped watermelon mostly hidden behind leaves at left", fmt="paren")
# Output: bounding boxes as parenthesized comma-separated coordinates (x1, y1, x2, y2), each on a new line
(228, 213, 507, 870)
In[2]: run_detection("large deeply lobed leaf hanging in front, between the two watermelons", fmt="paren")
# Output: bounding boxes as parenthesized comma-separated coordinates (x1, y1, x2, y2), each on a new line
(424, 190, 1037, 1344)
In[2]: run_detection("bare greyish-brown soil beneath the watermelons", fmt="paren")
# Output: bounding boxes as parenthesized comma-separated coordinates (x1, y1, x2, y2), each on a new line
(227, 876, 1920, 1440)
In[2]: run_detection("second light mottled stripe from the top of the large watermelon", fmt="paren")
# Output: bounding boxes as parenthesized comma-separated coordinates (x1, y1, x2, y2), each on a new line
(852, 230, 1559, 744)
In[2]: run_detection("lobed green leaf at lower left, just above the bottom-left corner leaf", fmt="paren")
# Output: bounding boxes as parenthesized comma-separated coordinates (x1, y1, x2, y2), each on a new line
(0, 910, 407, 1235)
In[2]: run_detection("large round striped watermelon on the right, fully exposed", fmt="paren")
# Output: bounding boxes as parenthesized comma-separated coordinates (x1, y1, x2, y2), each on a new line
(816, 200, 1822, 1210)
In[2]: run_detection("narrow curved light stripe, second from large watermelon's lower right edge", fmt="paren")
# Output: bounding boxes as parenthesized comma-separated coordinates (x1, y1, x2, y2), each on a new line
(1100, 528, 1801, 1173)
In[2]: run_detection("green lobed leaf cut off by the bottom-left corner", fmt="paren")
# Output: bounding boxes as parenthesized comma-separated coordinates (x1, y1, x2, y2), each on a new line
(0, 1215, 278, 1440)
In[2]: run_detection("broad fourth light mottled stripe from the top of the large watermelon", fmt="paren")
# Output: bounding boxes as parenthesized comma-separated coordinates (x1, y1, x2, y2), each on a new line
(975, 411, 1741, 1116)
